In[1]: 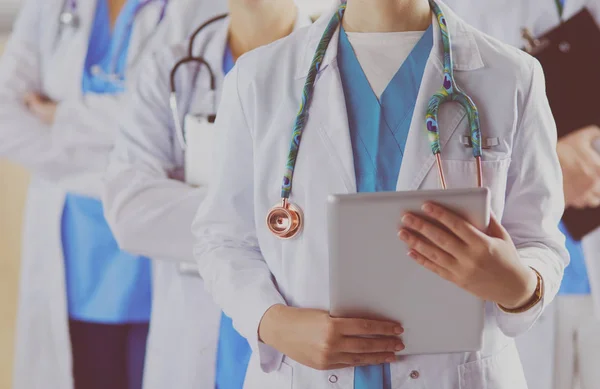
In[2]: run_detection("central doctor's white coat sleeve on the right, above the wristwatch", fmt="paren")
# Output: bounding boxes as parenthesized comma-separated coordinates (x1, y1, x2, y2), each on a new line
(495, 59, 569, 337)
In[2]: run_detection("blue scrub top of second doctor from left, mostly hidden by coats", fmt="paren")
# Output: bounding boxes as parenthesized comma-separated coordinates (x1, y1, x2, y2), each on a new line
(214, 46, 252, 389)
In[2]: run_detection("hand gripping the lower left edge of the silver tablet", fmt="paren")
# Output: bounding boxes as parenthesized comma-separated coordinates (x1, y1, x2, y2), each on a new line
(259, 305, 404, 370)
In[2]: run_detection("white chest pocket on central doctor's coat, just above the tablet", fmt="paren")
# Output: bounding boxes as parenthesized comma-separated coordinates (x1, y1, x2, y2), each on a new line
(435, 158, 511, 216)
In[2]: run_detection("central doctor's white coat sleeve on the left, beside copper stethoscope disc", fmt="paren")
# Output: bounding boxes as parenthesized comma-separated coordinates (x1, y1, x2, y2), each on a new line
(192, 65, 286, 372)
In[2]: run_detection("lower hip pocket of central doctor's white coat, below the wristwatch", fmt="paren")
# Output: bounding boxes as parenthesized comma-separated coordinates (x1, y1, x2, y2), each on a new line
(458, 343, 527, 389)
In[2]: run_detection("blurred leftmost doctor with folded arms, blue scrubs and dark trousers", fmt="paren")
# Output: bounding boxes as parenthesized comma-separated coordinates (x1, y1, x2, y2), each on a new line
(0, 0, 223, 389)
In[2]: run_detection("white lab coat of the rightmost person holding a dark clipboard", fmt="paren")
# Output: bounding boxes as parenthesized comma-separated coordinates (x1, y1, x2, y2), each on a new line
(447, 0, 600, 389)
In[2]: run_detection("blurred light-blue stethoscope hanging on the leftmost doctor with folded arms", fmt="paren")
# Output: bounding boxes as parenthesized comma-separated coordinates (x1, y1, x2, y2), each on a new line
(59, 0, 169, 84)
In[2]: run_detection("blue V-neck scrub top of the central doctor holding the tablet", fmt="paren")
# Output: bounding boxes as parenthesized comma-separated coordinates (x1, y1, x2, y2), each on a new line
(338, 27, 433, 389)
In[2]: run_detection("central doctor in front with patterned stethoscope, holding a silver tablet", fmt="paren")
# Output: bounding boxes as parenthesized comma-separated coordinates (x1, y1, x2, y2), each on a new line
(192, 0, 568, 389)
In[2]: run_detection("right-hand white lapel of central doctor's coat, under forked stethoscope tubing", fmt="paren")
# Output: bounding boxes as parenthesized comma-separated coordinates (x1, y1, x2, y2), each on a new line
(396, 2, 483, 191)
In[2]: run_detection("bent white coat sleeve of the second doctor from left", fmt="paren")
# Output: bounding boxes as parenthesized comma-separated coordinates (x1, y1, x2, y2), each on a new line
(103, 49, 206, 262)
